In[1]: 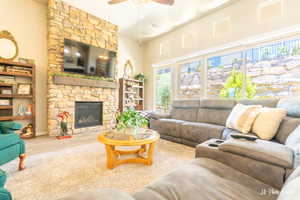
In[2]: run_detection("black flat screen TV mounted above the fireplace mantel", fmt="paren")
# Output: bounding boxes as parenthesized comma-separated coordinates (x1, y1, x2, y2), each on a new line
(64, 39, 116, 78)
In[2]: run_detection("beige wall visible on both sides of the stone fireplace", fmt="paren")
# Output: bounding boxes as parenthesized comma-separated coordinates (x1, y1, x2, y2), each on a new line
(0, 0, 143, 135)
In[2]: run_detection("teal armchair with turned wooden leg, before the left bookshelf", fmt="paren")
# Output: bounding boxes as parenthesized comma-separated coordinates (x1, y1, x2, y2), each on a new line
(0, 122, 26, 170)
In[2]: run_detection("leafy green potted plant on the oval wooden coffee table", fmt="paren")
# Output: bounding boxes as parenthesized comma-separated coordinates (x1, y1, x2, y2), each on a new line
(117, 109, 149, 133)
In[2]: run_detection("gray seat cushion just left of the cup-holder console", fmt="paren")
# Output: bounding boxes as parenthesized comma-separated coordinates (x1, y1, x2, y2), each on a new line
(180, 122, 225, 143)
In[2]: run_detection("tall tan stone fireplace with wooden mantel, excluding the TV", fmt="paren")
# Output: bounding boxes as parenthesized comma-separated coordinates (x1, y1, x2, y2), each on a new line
(47, 0, 118, 136)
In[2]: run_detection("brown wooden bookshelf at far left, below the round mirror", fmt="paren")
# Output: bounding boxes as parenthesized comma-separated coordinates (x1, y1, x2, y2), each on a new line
(0, 60, 36, 139)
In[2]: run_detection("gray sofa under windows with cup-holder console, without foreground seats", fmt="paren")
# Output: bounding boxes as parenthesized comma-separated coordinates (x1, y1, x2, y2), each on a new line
(150, 99, 300, 189)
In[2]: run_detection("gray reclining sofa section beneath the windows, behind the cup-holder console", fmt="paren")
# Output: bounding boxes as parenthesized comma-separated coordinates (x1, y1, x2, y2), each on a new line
(150, 99, 300, 147)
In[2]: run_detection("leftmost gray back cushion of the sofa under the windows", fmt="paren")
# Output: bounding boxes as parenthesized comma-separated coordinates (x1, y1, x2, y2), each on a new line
(170, 100, 200, 122)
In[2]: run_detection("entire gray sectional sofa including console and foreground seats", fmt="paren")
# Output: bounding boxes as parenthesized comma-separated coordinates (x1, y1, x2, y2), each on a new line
(62, 99, 300, 200)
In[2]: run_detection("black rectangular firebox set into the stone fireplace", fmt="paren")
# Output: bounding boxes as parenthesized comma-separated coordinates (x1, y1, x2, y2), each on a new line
(75, 101, 103, 129)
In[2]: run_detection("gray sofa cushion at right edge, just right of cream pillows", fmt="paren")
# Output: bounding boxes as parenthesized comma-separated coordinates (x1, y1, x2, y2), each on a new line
(275, 117, 300, 144)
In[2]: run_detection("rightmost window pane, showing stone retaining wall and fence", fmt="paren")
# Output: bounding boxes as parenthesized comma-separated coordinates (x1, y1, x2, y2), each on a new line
(246, 39, 300, 98)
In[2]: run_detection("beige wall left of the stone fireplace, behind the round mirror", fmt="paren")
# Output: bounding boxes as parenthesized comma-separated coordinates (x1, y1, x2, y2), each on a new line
(0, 0, 47, 134)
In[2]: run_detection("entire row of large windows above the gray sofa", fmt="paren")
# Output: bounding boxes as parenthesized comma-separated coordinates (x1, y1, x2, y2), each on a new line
(155, 35, 300, 110)
